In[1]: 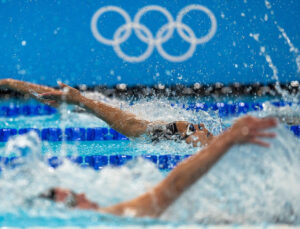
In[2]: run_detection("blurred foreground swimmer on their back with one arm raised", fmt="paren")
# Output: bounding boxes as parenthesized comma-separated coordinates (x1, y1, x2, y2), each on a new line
(39, 116, 276, 218)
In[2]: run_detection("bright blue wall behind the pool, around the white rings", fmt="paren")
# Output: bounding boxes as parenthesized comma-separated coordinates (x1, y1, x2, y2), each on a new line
(0, 0, 300, 85)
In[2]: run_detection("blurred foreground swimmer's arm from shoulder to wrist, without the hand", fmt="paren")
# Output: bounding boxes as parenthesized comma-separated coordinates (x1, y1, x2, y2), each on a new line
(99, 127, 234, 217)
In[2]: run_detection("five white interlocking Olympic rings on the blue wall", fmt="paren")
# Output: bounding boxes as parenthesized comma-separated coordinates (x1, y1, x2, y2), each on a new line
(91, 4, 217, 63)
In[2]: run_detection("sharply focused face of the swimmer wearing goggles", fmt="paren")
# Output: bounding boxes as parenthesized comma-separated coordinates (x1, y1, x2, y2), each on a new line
(176, 121, 213, 147)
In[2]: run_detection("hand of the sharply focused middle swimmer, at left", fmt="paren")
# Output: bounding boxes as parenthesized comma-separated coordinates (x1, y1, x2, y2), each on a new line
(38, 82, 81, 107)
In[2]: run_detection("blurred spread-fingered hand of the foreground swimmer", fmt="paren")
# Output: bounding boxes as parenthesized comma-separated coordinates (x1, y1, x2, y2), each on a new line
(228, 116, 277, 147)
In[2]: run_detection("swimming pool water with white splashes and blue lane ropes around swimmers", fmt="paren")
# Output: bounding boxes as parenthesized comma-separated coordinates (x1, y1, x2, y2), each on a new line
(0, 95, 300, 227)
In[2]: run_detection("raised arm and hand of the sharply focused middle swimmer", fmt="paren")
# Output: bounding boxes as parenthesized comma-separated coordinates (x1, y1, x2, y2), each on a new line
(41, 83, 150, 137)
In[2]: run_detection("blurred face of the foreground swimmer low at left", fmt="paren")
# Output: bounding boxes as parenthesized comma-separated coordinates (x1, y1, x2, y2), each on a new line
(54, 188, 98, 209)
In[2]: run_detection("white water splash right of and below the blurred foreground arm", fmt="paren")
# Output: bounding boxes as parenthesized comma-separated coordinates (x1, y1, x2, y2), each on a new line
(162, 126, 300, 224)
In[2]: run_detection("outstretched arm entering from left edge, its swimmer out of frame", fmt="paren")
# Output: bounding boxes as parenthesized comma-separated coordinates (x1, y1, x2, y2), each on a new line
(0, 79, 57, 98)
